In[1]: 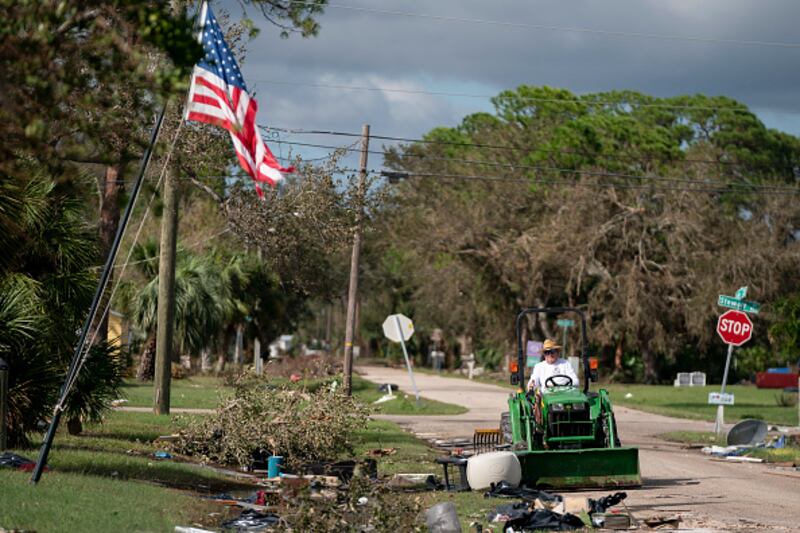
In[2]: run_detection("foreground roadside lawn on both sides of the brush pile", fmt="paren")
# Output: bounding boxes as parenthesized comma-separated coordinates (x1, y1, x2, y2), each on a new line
(0, 400, 482, 532)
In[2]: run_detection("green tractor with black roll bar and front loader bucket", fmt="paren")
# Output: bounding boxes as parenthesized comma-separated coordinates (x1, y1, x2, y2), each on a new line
(500, 307, 641, 488)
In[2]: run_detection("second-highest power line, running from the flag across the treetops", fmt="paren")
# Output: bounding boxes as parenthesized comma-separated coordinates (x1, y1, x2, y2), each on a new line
(253, 79, 800, 115)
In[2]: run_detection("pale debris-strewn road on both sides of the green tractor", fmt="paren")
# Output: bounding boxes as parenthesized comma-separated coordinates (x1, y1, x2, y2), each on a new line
(357, 367, 800, 531)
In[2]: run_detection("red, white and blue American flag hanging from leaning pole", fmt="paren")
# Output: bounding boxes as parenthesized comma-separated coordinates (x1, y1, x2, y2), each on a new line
(186, 2, 294, 198)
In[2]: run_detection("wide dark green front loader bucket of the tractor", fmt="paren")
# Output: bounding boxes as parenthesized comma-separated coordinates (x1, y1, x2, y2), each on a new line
(516, 448, 642, 489)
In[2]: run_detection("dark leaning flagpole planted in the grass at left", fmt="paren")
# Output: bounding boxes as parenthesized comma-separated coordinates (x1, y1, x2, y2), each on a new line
(31, 102, 167, 484)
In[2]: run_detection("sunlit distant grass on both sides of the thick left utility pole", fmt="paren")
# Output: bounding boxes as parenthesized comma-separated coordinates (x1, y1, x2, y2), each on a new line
(122, 376, 231, 409)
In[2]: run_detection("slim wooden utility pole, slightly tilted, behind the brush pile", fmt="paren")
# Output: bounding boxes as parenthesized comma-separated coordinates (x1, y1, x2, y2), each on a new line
(342, 124, 369, 396)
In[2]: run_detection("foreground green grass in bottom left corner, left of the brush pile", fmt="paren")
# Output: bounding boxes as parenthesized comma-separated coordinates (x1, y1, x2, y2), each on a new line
(0, 412, 250, 532)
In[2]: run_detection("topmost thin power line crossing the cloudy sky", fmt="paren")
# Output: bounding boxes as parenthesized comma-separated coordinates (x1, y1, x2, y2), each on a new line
(289, 0, 800, 49)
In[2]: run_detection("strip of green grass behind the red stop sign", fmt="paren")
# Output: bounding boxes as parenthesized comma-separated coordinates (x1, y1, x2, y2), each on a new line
(601, 384, 798, 426)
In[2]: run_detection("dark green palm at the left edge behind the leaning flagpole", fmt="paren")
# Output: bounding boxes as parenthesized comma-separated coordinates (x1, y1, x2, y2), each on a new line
(0, 161, 121, 446)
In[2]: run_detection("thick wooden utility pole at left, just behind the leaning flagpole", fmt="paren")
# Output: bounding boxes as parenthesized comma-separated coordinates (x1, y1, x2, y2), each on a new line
(153, 167, 179, 415)
